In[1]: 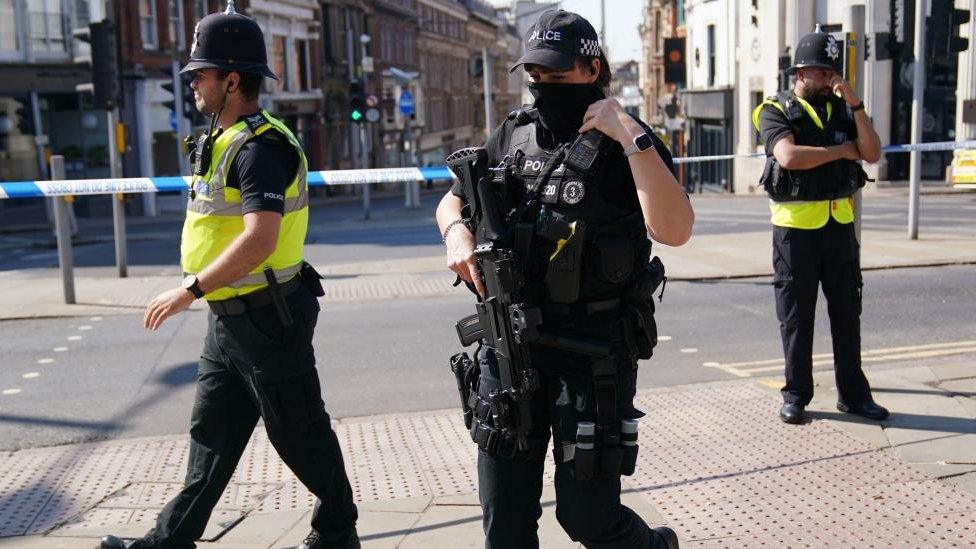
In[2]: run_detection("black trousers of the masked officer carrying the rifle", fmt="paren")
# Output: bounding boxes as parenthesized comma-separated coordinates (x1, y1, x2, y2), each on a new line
(478, 322, 666, 549)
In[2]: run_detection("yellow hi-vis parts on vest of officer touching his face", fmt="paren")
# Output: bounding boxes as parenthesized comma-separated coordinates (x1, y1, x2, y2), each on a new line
(752, 97, 854, 229)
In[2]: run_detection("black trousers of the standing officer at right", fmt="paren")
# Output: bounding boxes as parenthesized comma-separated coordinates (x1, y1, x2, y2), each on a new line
(773, 218, 871, 406)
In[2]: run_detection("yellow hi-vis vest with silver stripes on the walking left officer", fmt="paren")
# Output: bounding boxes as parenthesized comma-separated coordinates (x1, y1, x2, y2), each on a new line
(180, 111, 308, 301)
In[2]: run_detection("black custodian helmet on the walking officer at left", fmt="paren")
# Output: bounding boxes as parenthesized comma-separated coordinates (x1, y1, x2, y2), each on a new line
(180, 0, 278, 80)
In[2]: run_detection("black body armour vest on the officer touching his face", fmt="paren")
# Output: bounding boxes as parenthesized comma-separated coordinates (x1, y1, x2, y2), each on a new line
(760, 91, 867, 202)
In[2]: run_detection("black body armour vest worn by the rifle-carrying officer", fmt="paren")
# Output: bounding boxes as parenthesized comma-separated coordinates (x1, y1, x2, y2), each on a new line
(507, 115, 651, 303)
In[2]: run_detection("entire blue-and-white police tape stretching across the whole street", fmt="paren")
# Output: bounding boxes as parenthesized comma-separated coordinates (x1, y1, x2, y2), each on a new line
(0, 140, 976, 200)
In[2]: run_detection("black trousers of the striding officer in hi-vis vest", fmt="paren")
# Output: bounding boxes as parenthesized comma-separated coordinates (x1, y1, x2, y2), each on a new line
(144, 287, 357, 549)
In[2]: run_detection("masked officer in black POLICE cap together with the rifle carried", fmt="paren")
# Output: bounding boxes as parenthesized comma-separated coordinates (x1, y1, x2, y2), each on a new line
(437, 10, 694, 549)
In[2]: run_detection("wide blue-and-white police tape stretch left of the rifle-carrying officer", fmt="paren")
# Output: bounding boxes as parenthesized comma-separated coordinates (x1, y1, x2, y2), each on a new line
(0, 166, 454, 200)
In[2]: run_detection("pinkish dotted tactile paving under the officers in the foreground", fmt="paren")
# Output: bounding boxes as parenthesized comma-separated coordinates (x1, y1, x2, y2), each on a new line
(0, 381, 976, 549)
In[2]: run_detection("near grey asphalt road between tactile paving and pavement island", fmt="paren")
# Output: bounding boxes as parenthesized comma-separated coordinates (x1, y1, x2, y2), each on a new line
(0, 266, 976, 450)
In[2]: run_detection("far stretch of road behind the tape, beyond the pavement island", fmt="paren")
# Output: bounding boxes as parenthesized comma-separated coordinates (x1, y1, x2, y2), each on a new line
(0, 193, 976, 272)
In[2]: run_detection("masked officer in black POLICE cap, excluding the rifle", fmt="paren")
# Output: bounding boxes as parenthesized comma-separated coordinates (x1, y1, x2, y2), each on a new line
(437, 10, 694, 549)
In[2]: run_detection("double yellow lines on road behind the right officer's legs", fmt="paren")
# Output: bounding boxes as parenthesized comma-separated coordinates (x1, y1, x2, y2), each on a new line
(702, 340, 976, 377)
